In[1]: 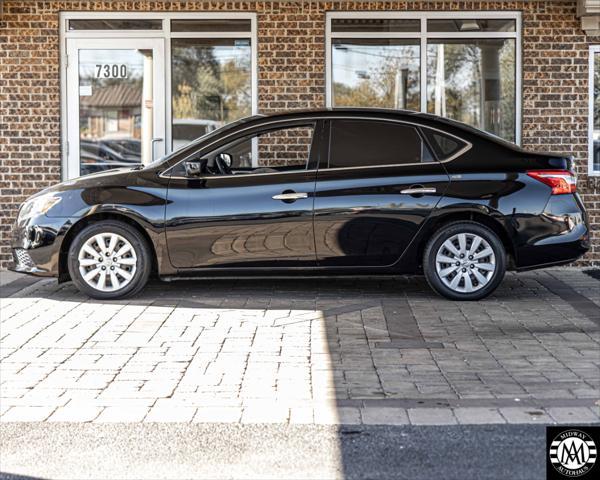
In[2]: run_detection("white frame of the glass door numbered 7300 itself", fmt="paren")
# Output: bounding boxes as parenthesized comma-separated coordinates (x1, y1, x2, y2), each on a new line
(64, 38, 166, 178)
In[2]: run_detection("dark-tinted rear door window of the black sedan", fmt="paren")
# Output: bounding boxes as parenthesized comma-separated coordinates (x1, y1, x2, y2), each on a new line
(329, 120, 433, 168)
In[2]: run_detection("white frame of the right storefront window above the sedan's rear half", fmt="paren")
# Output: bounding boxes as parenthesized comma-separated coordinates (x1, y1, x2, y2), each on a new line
(325, 10, 523, 145)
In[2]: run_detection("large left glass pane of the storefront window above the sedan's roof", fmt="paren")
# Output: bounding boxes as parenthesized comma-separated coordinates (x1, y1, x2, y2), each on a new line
(333, 45, 419, 110)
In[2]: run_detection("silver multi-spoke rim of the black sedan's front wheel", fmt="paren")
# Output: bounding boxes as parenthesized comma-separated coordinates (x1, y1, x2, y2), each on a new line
(78, 233, 137, 292)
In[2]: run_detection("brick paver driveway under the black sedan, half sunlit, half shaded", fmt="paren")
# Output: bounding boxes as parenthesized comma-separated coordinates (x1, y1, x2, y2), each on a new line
(0, 269, 600, 424)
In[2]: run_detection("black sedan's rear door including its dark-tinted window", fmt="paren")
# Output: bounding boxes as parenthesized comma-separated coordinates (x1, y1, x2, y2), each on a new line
(314, 118, 449, 267)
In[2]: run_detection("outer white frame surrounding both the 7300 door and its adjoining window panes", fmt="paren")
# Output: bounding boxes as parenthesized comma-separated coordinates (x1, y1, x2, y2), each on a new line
(59, 11, 258, 180)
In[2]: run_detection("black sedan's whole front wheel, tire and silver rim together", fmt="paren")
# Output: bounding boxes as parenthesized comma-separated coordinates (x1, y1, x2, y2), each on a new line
(68, 220, 151, 299)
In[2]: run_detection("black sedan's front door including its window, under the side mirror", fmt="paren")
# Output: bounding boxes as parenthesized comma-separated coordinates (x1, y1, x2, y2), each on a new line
(166, 124, 319, 269)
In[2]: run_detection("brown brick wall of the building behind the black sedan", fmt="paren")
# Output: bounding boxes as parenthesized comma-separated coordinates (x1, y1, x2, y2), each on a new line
(0, 0, 600, 266)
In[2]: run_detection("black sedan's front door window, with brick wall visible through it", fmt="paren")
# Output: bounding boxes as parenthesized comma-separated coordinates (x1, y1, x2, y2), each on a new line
(173, 124, 314, 176)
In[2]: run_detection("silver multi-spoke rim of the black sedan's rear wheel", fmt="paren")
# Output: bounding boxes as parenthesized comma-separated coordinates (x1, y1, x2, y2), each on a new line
(435, 233, 496, 293)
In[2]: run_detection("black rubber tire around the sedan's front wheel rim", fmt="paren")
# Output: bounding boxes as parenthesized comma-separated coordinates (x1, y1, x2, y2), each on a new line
(67, 220, 152, 300)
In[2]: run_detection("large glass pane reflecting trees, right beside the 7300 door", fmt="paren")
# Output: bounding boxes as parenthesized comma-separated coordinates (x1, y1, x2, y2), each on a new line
(173, 45, 252, 123)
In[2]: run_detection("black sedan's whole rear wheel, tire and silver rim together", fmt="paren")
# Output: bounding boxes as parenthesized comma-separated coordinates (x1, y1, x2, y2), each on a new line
(423, 221, 506, 300)
